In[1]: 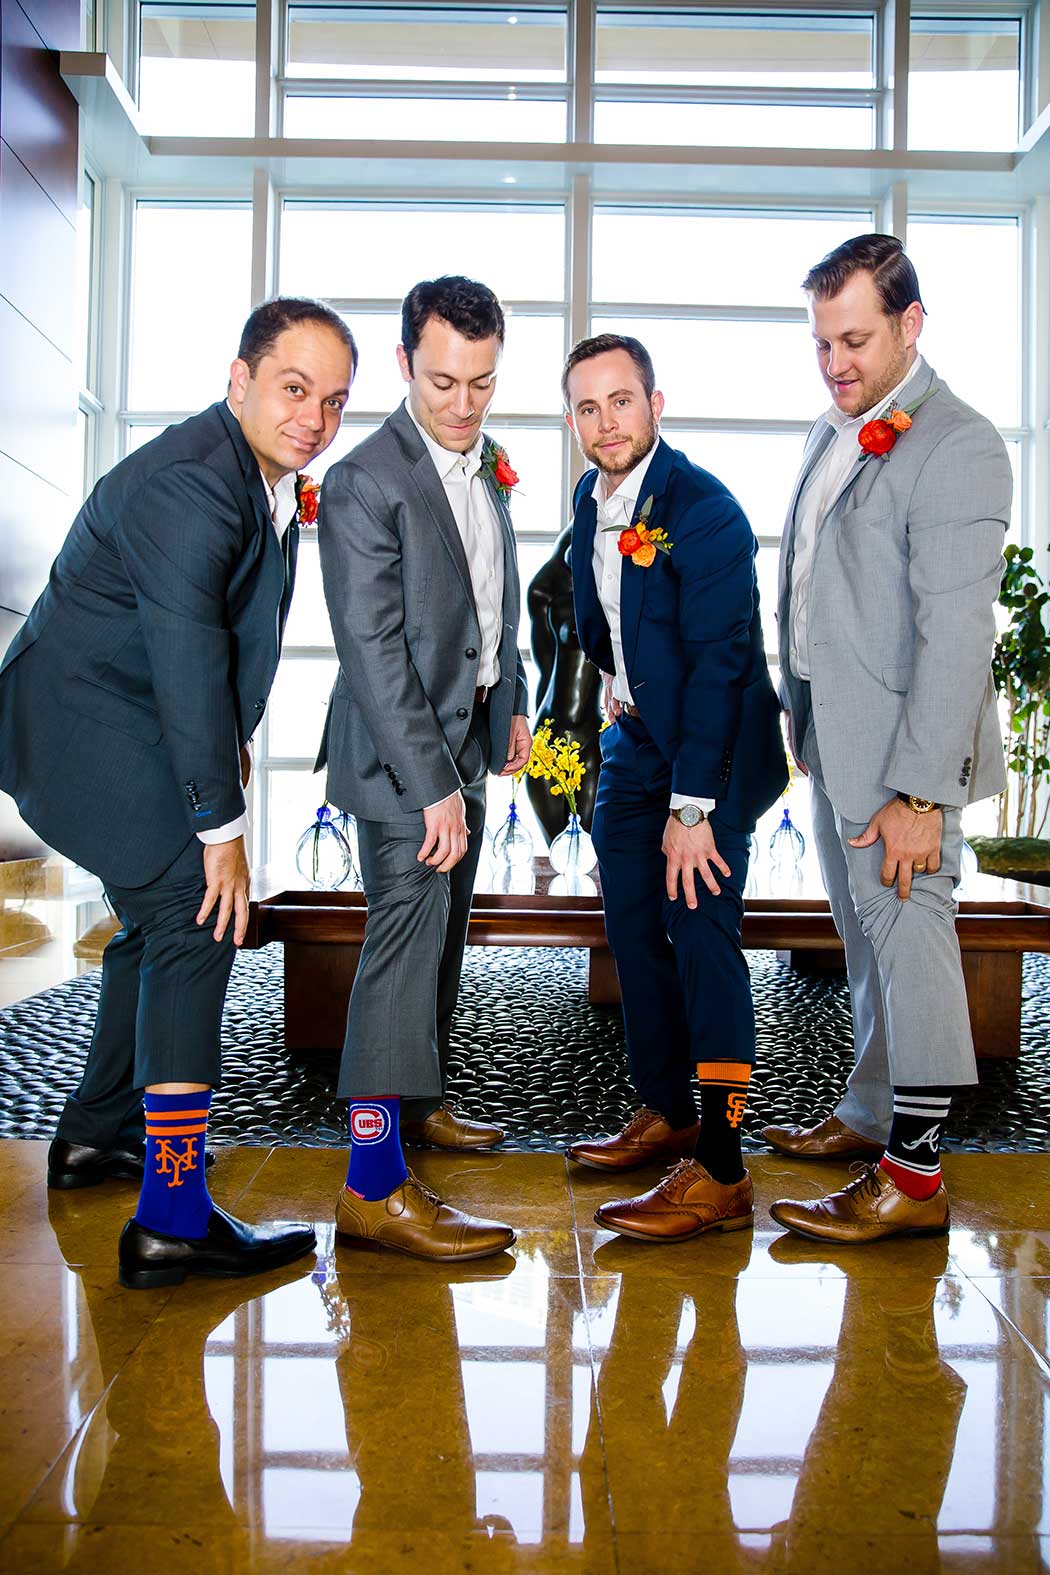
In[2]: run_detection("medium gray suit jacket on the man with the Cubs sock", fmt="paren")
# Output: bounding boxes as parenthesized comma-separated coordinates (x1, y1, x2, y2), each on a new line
(316, 405, 527, 821)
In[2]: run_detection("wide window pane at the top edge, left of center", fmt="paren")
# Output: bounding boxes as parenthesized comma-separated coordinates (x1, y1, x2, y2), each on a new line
(288, 5, 565, 82)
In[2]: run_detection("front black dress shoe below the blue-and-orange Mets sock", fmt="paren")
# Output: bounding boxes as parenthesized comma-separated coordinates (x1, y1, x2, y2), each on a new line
(118, 1208, 316, 1290)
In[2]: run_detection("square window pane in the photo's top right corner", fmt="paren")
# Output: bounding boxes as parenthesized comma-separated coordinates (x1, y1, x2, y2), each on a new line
(908, 16, 1020, 151)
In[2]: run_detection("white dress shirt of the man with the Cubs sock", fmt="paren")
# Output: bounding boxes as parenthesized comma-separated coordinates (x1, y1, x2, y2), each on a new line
(406, 403, 504, 688)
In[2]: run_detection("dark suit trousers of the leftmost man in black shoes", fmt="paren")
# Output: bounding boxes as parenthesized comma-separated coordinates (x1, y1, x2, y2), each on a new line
(58, 836, 236, 1148)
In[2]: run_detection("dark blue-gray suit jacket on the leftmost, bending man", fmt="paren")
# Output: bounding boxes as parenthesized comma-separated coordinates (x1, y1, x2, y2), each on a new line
(0, 402, 299, 887)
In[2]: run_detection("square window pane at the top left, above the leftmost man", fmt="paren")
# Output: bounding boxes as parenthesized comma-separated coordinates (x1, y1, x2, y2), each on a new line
(139, 5, 255, 137)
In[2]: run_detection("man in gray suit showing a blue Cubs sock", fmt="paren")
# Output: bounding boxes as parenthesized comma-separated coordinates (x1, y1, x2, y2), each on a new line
(318, 267, 532, 1258)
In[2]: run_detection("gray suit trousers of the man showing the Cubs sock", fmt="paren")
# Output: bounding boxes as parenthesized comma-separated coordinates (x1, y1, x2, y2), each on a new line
(337, 701, 490, 1121)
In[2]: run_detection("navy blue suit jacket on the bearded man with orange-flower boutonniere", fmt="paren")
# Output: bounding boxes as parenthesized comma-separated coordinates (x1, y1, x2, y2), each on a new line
(570, 438, 787, 830)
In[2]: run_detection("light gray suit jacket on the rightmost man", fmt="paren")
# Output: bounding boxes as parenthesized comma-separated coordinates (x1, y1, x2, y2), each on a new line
(778, 367, 1012, 822)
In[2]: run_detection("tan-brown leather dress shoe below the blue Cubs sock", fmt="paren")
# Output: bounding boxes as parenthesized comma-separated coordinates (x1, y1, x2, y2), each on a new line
(335, 1170, 516, 1263)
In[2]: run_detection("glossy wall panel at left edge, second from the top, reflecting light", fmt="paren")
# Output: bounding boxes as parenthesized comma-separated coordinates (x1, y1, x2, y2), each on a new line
(0, 140, 77, 359)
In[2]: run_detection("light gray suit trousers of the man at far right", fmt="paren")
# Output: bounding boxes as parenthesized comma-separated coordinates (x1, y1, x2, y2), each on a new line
(801, 708, 978, 1143)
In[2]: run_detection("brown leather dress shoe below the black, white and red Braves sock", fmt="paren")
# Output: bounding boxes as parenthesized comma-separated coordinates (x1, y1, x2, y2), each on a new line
(770, 1166, 951, 1246)
